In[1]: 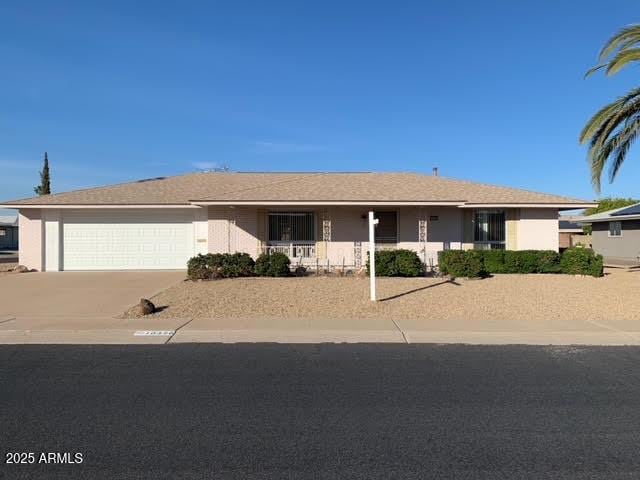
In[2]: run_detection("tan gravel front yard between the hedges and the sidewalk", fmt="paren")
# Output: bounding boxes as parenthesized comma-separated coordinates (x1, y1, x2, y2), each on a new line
(135, 270, 640, 320)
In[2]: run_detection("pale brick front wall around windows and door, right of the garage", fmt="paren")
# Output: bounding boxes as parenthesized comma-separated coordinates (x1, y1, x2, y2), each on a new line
(208, 206, 558, 266)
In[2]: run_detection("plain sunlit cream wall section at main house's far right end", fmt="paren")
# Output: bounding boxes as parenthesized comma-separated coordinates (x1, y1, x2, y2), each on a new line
(515, 208, 559, 252)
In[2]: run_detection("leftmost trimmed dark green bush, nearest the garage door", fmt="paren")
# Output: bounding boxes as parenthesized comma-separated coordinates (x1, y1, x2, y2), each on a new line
(187, 253, 255, 280)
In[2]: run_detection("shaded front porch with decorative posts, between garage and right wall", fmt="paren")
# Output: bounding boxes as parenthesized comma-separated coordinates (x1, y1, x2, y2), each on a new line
(208, 206, 513, 269)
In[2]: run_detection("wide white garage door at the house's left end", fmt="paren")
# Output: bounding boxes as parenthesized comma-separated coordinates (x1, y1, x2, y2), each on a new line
(62, 210, 194, 270)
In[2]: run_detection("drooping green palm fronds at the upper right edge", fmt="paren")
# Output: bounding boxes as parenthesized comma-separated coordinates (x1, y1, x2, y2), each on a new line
(580, 24, 640, 193)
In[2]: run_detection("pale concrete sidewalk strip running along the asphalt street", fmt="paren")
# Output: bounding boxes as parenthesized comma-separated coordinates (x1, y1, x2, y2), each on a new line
(0, 316, 640, 345)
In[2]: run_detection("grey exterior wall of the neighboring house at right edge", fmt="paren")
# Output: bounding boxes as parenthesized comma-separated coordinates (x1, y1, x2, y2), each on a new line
(591, 220, 640, 263)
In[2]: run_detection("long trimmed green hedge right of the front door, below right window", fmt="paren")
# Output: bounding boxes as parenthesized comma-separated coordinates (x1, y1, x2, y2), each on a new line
(438, 248, 603, 278)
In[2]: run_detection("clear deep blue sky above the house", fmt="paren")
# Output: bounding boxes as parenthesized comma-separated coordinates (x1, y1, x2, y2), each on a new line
(0, 0, 640, 213)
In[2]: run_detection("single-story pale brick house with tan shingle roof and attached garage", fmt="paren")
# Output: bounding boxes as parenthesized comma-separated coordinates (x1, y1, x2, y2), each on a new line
(0, 172, 596, 271)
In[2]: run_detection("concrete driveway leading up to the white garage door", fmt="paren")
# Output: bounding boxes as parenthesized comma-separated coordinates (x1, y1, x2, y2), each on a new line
(0, 271, 185, 322)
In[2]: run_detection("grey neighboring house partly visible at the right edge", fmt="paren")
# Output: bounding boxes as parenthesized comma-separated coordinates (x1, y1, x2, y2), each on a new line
(580, 203, 640, 265)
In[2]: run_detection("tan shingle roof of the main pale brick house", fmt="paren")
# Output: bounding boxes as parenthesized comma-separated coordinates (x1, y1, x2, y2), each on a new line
(3, 172, 591, 207)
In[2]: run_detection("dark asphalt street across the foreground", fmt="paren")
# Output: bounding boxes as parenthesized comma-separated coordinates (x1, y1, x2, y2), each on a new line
(0, 344, 640, 479)
